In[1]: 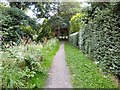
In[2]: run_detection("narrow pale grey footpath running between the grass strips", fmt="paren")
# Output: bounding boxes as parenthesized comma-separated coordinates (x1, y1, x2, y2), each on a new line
(45, 42, 72, 88)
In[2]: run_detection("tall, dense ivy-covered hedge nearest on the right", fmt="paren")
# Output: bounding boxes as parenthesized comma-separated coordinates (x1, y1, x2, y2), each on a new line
(69, 3, 120, 78)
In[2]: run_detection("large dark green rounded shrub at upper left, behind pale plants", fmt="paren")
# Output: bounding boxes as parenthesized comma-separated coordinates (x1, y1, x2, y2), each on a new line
(0, 4, 37, 48)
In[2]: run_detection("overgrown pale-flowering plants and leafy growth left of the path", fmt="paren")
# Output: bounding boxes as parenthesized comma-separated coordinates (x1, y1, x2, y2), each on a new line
(0, 39, 58, 88)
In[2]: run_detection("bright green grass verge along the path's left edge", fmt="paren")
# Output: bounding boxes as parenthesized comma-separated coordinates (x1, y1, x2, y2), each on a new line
(29, 42, 60, 88)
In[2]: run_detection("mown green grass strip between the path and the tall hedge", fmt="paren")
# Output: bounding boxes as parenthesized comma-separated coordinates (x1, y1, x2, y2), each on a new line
(65, 43, 117, 88)
